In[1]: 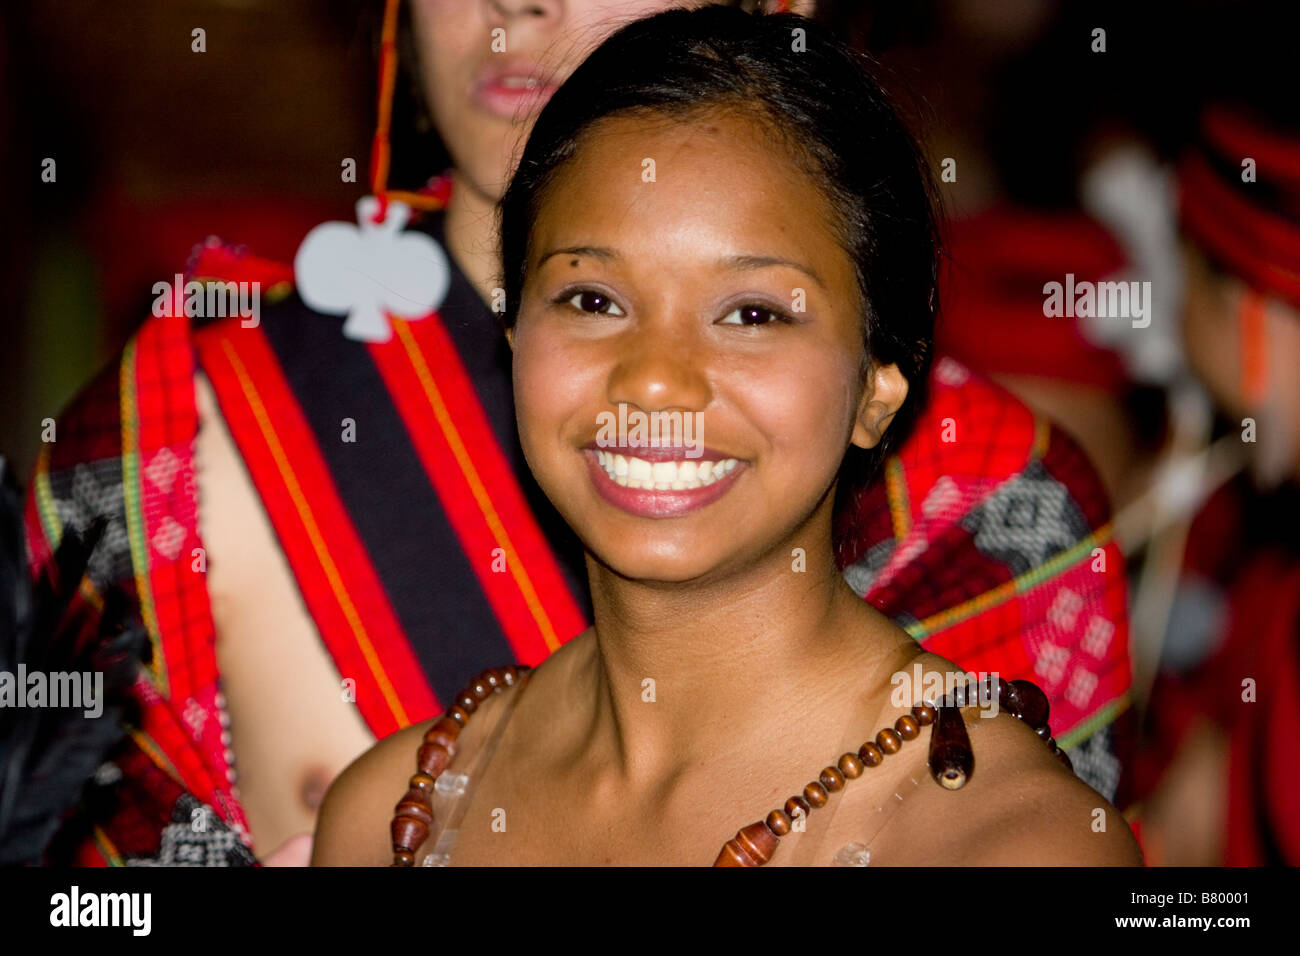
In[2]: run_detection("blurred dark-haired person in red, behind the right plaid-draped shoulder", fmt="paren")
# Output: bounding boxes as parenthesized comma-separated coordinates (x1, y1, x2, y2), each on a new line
(865, 0, 1195, 530)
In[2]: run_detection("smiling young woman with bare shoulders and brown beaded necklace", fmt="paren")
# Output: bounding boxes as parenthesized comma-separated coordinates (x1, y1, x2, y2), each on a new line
(315, 8, 1140, 865)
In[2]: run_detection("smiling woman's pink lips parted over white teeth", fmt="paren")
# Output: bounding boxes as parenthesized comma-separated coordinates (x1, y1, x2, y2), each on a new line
(584, 446, 745, 518)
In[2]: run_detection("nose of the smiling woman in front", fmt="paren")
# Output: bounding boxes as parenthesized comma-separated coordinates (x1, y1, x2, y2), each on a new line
(607, 329, 712, 412)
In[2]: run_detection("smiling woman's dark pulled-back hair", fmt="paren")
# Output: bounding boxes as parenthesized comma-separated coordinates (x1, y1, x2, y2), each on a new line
(499, 7, 939, 554)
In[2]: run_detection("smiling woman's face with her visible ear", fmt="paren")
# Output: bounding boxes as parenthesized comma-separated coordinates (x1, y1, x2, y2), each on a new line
(512, 112, 906, 581)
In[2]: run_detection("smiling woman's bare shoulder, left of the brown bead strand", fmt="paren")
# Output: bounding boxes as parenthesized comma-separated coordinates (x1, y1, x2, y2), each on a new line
(312, 721, 433, 866)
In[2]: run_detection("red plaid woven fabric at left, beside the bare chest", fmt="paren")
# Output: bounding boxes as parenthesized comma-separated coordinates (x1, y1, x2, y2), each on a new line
(26, 317, 251, 862)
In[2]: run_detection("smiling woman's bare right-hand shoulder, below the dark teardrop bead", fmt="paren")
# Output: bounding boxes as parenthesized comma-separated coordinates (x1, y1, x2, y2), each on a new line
(879, 654, 1143, 866)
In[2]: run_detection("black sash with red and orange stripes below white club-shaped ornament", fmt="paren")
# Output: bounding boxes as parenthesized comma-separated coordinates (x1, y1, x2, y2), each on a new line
(195, 215, 590, 736)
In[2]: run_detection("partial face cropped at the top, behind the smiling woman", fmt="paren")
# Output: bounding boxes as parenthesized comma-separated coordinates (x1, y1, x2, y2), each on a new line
(411, 0, 701, 200)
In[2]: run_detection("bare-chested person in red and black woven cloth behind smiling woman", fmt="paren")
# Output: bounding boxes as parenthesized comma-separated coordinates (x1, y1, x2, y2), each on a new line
(0, 0, 1128, 865)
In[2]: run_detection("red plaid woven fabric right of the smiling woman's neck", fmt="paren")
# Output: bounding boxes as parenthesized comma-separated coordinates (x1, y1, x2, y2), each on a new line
(845, 358, 1131, 754)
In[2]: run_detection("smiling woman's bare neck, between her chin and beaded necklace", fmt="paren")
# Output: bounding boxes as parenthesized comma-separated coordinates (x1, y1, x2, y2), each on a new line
(581, 512, 913, 787)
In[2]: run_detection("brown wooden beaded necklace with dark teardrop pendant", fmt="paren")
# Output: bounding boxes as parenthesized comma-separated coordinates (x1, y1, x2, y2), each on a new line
(391, 665, 1074, 866)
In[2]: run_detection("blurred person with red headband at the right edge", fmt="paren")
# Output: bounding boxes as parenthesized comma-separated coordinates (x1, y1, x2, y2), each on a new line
(1139, 85, 1300, 866)
